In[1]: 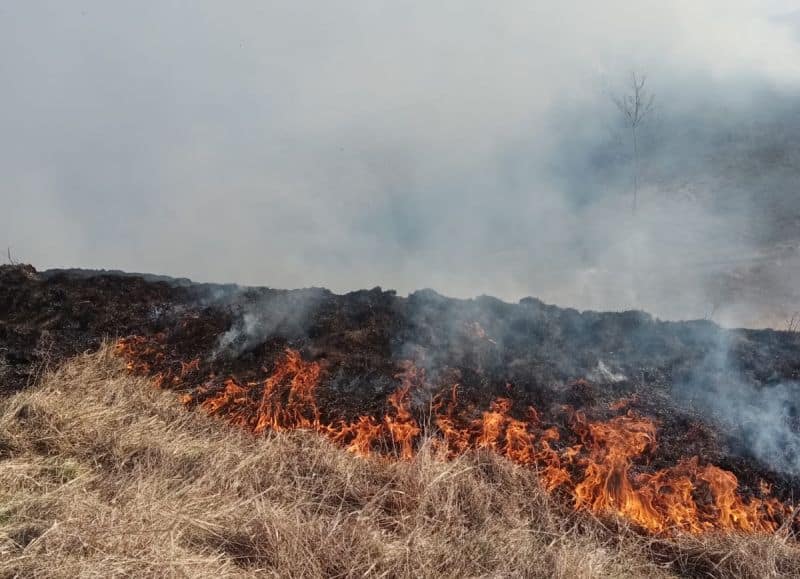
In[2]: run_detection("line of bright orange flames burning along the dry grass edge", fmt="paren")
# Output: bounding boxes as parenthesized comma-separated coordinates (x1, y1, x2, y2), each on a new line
(117, 337, 792, 534)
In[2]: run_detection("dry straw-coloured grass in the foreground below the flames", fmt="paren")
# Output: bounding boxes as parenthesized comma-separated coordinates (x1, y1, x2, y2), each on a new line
(0, 350, 800, 578)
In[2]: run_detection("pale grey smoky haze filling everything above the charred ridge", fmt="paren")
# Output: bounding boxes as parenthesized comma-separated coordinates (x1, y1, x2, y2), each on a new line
(0, 0, 800, 327)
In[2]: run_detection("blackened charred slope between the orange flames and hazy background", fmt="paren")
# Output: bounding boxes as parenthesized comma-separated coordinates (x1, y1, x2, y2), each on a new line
(0, 265, 800, 497)
